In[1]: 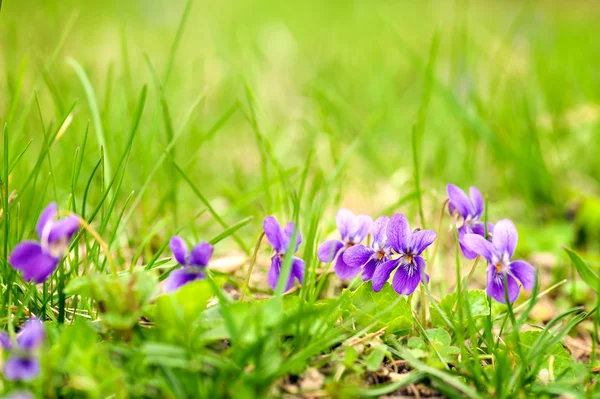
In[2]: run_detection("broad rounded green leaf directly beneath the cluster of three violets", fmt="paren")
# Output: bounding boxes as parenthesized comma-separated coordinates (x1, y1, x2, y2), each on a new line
(348, 281, 413, 333)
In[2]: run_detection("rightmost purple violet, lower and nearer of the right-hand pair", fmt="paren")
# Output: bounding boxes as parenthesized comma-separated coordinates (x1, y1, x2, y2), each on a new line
(464, 219, 535, 303)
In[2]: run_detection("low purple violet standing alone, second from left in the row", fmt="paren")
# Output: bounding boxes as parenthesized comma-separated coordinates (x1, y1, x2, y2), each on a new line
(165, 236, 214, 292)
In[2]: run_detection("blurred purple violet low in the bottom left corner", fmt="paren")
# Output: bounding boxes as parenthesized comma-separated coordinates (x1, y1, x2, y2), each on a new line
(0, 317, 46, 381)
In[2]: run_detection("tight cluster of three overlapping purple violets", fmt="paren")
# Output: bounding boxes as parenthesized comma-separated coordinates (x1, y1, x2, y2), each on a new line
(318, 209, 437, 295)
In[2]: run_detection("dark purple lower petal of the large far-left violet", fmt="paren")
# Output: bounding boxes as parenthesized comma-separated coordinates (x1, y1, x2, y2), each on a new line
(8, 241, 59, 283)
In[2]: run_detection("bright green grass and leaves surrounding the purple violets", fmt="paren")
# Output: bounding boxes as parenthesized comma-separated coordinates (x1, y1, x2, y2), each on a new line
(0, 0, 600, 398)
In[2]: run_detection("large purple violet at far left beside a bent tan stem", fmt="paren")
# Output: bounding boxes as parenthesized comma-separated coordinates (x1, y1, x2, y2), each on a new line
(8, 202, 79, 283)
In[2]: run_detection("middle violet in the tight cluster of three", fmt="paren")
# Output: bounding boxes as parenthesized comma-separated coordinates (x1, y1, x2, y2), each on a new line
(343, 216, 392, 281)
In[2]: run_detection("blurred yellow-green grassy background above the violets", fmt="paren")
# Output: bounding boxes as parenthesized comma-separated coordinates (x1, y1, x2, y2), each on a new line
(0, 0, 600, 253)
